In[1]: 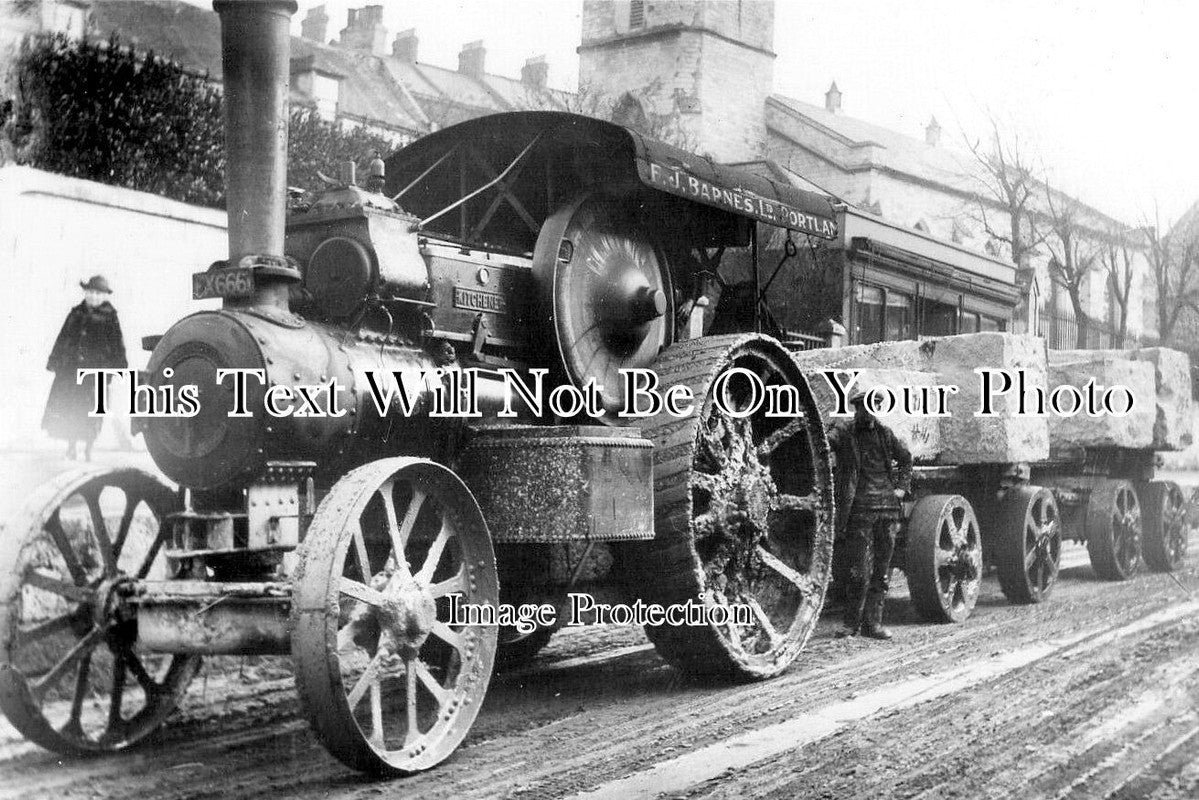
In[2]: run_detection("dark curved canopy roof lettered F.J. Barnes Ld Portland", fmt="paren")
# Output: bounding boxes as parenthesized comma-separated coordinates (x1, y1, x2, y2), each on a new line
(386, 112, 837, 252)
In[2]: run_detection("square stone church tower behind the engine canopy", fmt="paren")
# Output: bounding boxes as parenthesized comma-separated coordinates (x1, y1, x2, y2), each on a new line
(579, 0, 775, 162)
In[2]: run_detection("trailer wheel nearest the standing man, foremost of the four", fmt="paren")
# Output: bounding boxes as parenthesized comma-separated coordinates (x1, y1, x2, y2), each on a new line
(905, 494, 982, 622)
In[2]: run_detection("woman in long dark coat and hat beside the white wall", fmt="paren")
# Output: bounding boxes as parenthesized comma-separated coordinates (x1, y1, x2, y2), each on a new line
(42, 275, 128, 461)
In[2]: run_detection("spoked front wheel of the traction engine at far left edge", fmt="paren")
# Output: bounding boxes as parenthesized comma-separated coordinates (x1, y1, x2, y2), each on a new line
(0, 467, 200, 756)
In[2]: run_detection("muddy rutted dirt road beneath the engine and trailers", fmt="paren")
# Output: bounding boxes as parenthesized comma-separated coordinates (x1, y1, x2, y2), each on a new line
(0, 537, 1199, 800)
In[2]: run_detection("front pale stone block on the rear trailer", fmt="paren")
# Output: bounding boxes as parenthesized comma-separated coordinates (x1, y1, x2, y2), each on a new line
(1048, 350, 1157, 450)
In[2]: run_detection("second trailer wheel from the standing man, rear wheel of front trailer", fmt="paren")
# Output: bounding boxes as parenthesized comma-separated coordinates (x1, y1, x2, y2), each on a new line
(993, 486, 1061, 603)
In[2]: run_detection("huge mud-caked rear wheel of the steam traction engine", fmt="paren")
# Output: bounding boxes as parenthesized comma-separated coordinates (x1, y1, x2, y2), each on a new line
(623, 335, 832, 680)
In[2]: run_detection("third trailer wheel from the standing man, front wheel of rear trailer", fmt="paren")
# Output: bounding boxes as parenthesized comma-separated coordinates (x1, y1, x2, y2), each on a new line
(1086, 480, 1141, 581)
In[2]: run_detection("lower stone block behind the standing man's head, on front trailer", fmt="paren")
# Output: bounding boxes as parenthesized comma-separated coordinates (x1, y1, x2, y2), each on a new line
(808, 369, 953, 464)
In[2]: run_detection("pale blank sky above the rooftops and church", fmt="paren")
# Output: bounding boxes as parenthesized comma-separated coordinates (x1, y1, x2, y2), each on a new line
(193, 0, 1199, 225)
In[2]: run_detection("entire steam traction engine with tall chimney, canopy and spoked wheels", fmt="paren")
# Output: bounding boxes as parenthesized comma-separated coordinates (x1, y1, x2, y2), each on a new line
(0, 0, 836, 772)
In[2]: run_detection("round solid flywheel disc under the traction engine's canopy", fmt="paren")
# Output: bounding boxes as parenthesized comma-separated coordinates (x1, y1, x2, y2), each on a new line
(532, 192, 674, 417)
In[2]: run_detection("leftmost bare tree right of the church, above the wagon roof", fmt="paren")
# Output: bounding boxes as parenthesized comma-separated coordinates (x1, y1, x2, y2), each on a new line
(963, 116, 1044, 266)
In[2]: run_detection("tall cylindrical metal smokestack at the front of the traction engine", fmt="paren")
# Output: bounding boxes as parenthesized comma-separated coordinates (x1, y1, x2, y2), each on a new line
(212, 0, 300, 309)
